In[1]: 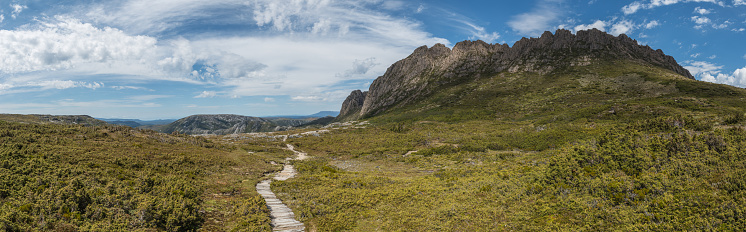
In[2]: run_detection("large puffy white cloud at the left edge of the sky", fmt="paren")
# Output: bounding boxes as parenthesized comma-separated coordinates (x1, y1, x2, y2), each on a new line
(0, 17, 156, 73)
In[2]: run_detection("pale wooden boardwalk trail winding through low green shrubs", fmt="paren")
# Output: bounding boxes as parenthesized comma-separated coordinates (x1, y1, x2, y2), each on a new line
(256, 144, 308, 232)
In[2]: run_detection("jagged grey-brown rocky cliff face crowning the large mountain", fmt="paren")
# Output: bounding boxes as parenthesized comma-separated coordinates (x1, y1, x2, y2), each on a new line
(337, 29, 694, 121)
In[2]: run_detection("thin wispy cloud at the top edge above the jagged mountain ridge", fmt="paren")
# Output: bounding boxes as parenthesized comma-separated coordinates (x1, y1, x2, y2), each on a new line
(508, 0, 563, 36)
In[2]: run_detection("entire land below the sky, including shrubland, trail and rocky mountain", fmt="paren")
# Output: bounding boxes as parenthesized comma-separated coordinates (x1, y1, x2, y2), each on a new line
(0, 29, 746, 231)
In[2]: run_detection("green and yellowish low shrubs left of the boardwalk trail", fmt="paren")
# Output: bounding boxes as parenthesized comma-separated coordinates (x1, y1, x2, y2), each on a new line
(0, 121, 289, 231)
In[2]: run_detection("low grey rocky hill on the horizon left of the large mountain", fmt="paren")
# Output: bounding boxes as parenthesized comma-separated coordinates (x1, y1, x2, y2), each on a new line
(161, 114, 277, 135)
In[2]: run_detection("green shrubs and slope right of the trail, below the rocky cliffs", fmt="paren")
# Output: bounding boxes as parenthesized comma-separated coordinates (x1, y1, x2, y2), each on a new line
(264, 63, 746, 231)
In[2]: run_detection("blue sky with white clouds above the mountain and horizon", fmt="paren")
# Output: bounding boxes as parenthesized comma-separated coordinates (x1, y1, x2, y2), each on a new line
(0, 0, 746, 120)
